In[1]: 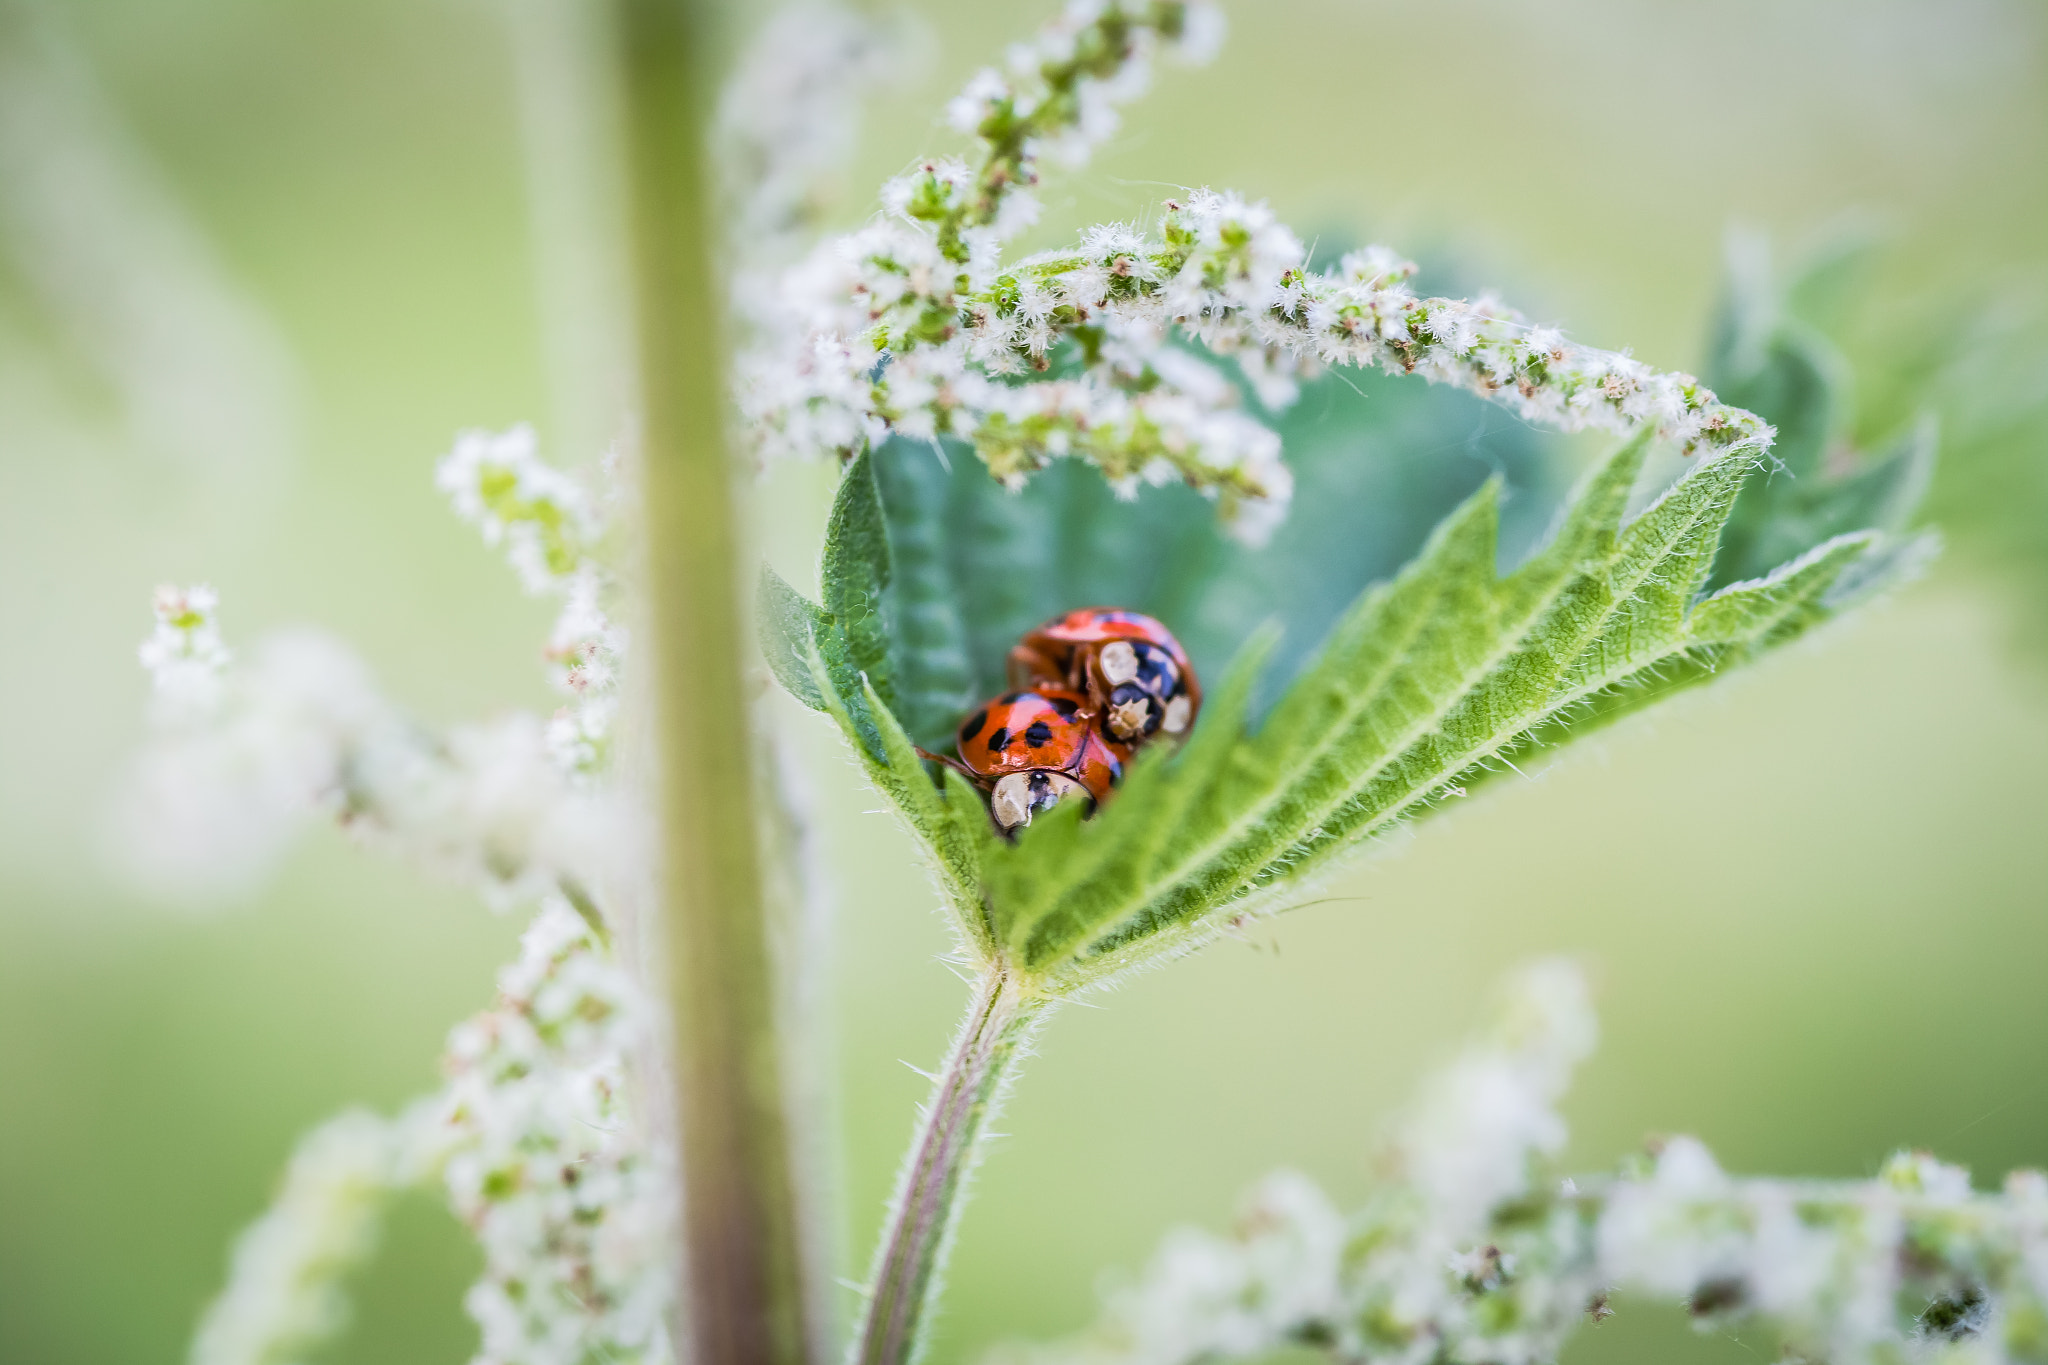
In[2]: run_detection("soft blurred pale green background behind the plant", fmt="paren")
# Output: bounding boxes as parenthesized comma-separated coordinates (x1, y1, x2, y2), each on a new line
(0, 0, 2048, 1365)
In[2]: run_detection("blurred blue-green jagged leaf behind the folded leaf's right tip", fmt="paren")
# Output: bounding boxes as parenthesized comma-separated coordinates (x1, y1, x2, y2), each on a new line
(1706, 239, 1935, 587)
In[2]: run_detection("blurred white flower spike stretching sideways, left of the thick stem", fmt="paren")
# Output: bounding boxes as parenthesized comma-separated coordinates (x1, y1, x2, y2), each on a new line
(115, 589, 610, 902)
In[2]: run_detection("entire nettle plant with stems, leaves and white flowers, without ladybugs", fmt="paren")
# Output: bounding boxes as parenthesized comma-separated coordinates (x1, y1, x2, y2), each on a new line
(129, 0, 2048, 1365)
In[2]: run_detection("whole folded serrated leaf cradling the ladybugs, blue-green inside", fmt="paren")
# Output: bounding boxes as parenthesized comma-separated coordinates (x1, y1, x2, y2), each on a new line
(762, 325, 1927, 995)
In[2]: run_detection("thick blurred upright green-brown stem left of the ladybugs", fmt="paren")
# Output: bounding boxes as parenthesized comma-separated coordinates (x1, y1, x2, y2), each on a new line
(616, 0, 805, 1365)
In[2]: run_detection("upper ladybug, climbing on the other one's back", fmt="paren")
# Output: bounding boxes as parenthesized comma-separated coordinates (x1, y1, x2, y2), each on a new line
(1010, 606, 1202, 745)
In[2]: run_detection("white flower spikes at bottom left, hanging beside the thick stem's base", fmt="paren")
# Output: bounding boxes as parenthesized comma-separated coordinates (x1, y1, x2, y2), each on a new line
(193, 896, 676, 1365)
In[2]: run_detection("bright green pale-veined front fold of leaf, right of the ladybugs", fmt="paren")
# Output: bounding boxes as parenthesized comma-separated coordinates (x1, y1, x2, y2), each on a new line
(985, 438, 1876, 990)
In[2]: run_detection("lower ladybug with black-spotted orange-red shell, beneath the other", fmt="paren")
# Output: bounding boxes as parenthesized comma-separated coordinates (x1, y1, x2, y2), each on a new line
(958, 688, 1128, 831)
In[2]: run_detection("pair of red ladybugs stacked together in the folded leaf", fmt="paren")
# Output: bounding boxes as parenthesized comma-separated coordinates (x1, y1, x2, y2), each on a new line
(942, 608, 1202, 831)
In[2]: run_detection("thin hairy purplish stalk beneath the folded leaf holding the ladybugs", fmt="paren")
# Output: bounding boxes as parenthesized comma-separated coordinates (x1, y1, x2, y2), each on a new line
(852, 968, 1044, 1365)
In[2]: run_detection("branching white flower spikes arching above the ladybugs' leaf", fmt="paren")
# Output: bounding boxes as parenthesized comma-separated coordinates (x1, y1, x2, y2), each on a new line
(737, 2, 1772, 542)
